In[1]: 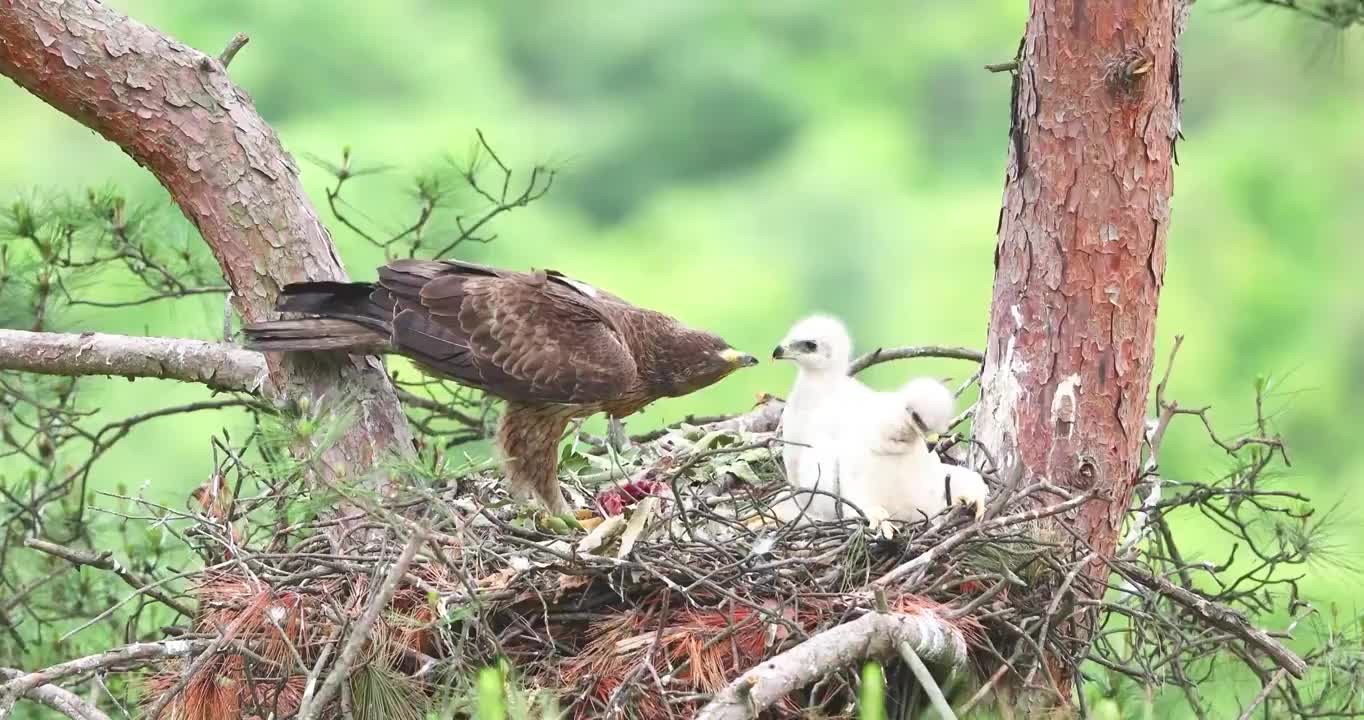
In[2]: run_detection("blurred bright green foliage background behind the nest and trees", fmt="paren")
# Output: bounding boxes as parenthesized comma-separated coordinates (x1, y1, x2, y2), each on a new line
(0, 0, 1364, 709)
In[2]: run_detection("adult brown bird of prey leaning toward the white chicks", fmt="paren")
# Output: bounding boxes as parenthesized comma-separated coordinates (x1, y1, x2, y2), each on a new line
(244, 260, 757, 513)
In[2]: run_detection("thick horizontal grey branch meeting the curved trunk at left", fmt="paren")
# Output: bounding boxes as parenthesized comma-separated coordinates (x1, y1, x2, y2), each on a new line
(0, 330, 269, 394)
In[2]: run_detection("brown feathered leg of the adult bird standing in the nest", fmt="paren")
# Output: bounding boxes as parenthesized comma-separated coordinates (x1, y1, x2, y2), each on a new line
(498, 402, 573, 514)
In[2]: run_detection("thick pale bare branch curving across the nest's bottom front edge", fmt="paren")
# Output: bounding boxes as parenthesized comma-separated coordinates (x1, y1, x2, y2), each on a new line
(696, 610, 967, 720)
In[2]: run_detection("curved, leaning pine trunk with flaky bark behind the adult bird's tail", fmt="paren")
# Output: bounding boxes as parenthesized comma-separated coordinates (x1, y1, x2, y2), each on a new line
(0, 0, 412, 468)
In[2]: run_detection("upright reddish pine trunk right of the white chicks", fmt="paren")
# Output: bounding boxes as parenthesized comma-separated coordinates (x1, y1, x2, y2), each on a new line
(975, 0, 1187, 697)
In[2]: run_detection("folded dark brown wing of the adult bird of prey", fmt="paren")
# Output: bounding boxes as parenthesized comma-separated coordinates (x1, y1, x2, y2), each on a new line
(372, 260, 637, 404)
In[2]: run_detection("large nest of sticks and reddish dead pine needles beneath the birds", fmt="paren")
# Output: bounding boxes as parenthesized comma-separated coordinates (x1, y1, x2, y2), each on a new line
(135, 401, 1078, 717)
